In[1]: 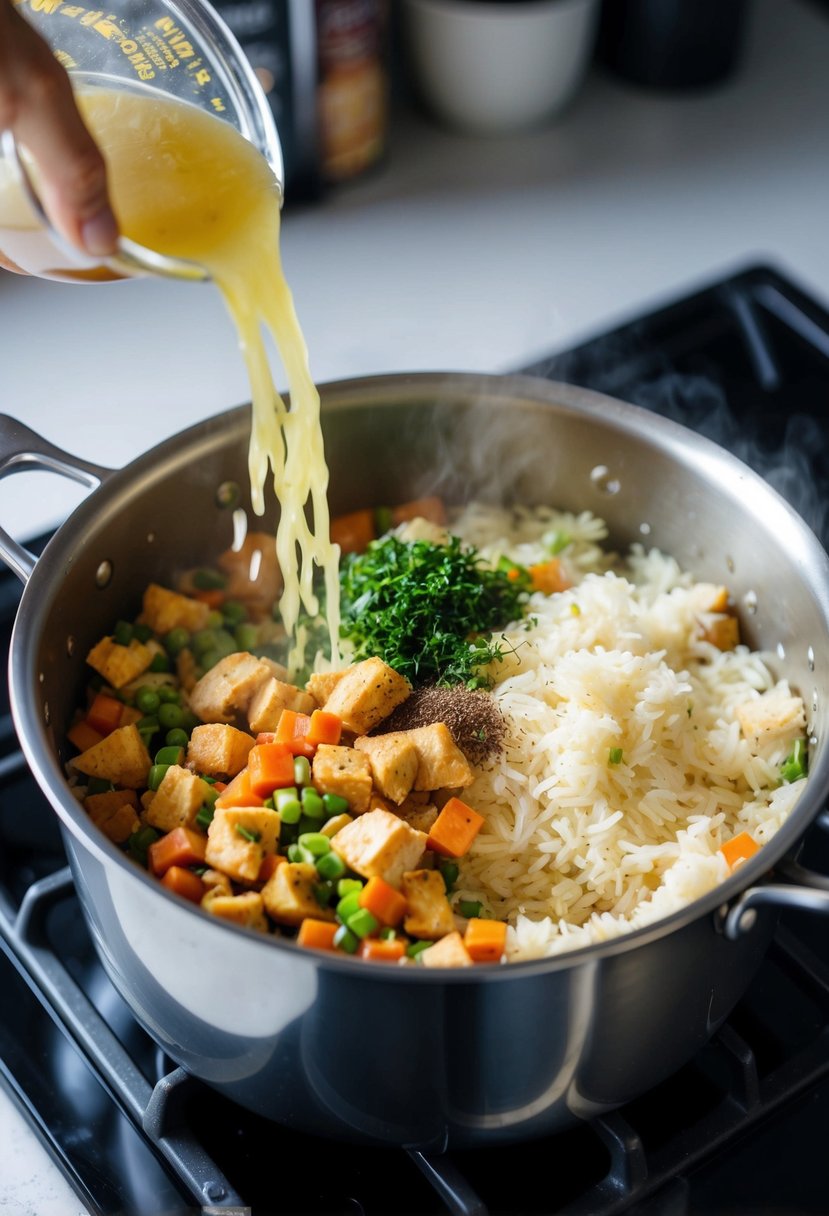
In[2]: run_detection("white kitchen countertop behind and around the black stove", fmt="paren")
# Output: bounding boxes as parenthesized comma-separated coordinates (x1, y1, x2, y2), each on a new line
(0, 0, 829, 1216)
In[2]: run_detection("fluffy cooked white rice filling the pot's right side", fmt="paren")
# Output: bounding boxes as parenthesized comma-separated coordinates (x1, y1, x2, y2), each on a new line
(442, 506, 805, 959)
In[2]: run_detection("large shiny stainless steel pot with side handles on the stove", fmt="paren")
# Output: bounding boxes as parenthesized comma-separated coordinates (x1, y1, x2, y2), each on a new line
(0, 375, 829, 1149)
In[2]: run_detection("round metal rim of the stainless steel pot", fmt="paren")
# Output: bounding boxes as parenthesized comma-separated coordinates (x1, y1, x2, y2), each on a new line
(9, 371, 829, 984)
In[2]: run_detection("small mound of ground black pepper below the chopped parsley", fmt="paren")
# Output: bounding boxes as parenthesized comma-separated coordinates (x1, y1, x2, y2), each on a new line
(372, 685, 504, 765)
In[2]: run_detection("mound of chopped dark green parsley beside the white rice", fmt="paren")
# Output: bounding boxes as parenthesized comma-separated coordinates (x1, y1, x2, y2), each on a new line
(340, 536, 528, 687)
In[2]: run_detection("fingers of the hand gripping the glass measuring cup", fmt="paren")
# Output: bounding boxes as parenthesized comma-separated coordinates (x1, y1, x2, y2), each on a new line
(0, 0, 118, 257)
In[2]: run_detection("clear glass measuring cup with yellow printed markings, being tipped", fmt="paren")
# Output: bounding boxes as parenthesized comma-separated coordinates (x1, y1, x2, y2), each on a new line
(0, 0, 283, 282)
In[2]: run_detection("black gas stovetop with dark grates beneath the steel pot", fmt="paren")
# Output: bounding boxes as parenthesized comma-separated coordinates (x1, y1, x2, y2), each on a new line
(0, 266, 829, 1216)
